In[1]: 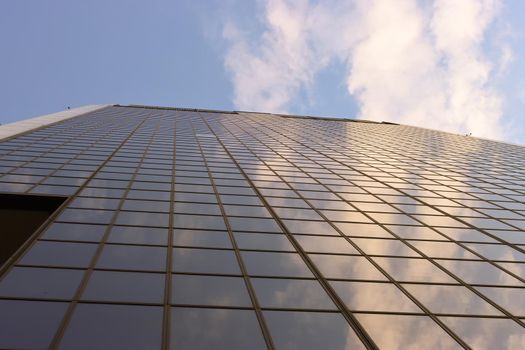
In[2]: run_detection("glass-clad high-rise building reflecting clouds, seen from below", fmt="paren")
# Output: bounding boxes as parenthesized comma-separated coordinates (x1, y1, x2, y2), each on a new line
(0, 106, 525, 350)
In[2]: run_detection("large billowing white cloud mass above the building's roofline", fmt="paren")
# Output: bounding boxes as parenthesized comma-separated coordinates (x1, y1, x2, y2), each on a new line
(224, 0, 513, 138)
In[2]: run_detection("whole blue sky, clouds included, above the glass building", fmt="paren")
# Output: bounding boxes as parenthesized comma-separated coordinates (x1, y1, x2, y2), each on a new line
(0, 0, 525, 144)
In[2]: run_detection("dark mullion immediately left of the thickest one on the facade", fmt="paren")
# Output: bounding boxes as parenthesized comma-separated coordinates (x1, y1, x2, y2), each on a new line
(191, 113, 275, 349)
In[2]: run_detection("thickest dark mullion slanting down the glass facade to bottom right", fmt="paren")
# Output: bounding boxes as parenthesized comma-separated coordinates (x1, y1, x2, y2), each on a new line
(199, 115, 378, 349)
